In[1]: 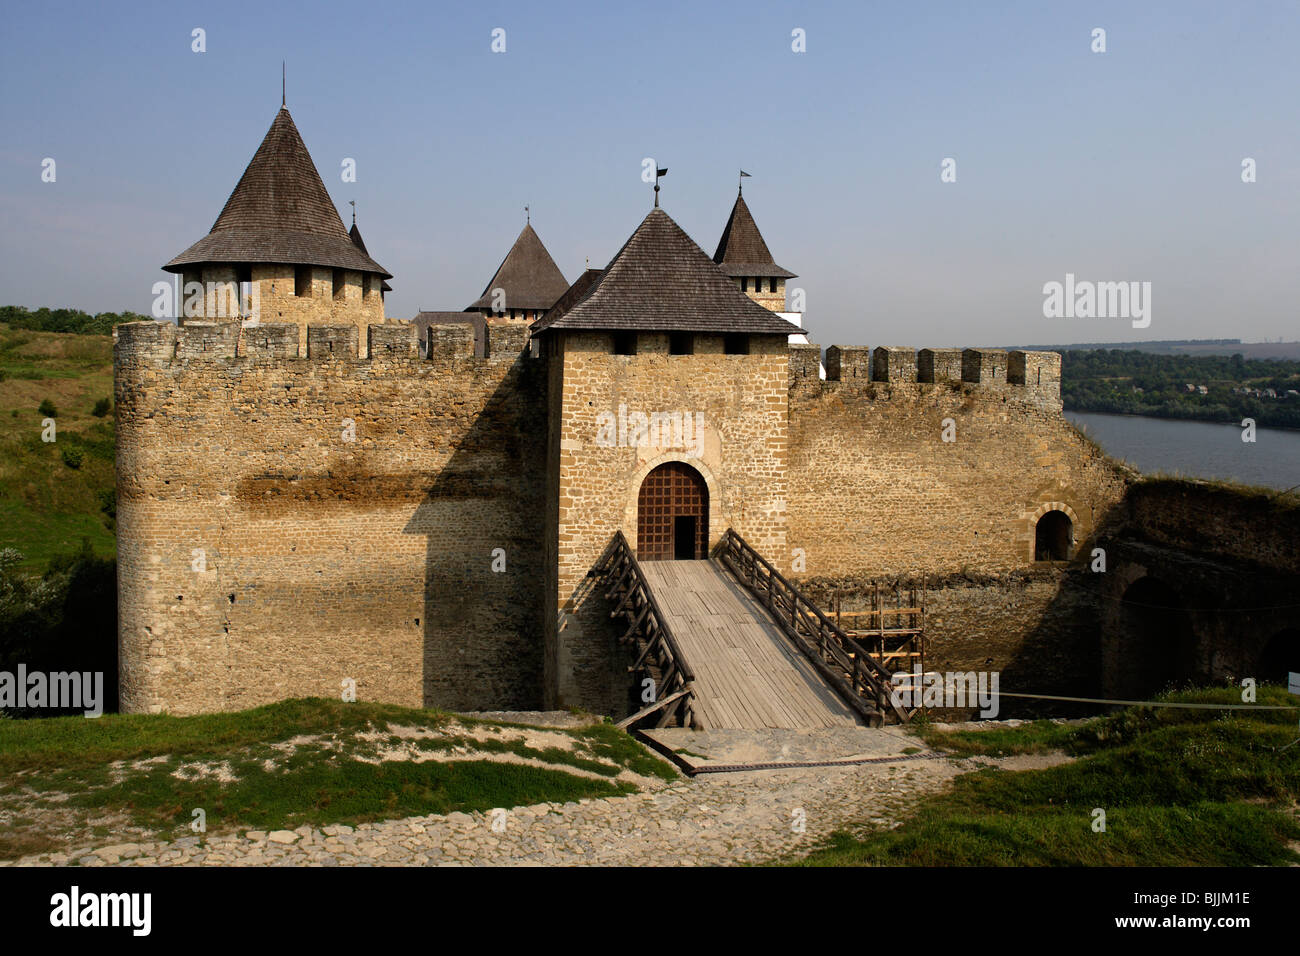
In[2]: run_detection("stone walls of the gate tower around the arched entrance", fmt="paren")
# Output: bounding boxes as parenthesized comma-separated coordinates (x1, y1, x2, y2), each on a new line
(547, 332, 789, 713)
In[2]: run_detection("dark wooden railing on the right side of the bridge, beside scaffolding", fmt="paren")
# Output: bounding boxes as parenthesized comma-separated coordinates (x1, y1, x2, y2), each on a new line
(714, 528, 911, 724)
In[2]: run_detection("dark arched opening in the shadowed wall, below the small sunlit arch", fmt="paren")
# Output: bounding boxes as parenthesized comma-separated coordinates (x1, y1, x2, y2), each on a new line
(1114, 575, 1199, 700)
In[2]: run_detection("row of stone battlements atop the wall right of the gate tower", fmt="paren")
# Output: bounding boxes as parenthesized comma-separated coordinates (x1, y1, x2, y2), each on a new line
(790, 345, 1061, 405)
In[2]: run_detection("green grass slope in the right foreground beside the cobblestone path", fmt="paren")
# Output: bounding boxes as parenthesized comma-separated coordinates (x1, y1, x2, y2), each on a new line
(801, 687, 1300, 866)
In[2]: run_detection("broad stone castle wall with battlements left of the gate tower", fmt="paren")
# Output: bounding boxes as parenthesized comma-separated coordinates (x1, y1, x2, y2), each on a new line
(114, 317, 546, 713)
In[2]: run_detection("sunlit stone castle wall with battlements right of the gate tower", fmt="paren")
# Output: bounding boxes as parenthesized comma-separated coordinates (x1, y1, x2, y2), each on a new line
(787, 345, 1125, 578)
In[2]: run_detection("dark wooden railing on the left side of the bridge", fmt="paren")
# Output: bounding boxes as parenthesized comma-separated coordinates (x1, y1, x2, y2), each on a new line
(588, 531, 696, 727)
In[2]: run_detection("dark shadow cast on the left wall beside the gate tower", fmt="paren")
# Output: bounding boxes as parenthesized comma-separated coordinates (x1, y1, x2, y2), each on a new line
(403, 335, 546, 710)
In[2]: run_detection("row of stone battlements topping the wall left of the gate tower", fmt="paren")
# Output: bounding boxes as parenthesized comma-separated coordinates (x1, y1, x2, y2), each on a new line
(113, 320, 528, 364)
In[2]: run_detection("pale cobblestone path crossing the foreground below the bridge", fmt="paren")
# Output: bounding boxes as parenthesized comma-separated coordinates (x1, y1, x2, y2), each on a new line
(0, 730, 995, 866)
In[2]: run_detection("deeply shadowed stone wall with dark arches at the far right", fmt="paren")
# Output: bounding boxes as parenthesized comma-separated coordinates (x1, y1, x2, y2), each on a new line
(1100, 480, 1300, 698)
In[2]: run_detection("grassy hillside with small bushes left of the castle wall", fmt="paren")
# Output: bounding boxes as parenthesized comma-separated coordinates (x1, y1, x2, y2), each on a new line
(0, 324, 116, 571)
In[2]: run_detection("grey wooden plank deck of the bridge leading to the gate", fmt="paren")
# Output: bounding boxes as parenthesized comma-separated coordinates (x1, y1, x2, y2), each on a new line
(641, 561, 862, 730)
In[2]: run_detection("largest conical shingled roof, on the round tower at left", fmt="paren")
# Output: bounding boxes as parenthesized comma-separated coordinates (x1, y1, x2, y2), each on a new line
(163, 107, 391, 278)
